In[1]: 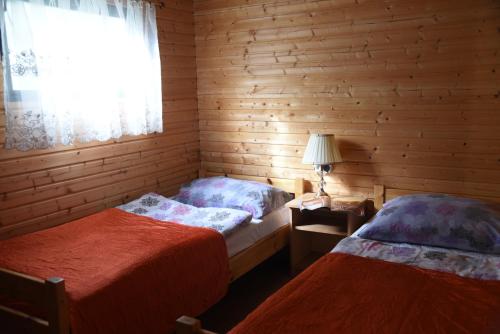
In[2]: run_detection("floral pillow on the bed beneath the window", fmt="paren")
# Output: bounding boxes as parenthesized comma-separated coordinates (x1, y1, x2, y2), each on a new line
(172, 176, 291, 218)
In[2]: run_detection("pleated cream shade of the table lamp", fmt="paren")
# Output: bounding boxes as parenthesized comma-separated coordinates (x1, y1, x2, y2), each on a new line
(302, 134, 342, 165)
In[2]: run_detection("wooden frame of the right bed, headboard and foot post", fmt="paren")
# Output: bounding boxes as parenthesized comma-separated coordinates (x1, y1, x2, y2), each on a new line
(176, 185, 500, 334)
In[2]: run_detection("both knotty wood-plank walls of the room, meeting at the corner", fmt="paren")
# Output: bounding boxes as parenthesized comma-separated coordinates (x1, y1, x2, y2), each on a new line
(0, 0, 500, 238)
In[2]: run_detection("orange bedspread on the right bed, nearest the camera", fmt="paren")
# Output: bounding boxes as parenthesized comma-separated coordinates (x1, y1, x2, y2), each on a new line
(230, 254, 500, 334)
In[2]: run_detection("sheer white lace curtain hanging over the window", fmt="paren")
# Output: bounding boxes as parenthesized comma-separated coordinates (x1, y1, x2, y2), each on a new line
(1, 0, 163, 150)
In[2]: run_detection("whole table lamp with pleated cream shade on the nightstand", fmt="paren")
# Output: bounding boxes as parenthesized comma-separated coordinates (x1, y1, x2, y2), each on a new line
(302, 133, 342, 197)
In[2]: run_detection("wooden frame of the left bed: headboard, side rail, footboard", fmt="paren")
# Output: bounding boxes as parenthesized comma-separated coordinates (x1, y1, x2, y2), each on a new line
(0, 170, 304, 334)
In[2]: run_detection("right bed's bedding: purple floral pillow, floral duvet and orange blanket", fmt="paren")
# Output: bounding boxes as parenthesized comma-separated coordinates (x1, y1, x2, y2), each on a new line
(231, 193, 500, 334)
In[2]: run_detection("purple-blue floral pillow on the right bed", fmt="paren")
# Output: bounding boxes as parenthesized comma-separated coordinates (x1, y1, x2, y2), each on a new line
(359, 194, 500, 254)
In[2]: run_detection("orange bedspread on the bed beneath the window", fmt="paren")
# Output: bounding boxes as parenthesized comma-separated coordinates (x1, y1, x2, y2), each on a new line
(0, 209, 230, 334)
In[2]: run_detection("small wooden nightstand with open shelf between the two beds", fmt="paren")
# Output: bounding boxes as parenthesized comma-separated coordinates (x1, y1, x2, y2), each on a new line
(287, 193, 367, 273)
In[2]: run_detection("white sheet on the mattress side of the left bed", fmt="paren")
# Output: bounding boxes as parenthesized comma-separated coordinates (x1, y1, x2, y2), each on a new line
(226, 206, 290, 257)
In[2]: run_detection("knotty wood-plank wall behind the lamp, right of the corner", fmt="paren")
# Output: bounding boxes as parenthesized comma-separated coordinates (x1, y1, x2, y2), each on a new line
(195, 0, 500, 197)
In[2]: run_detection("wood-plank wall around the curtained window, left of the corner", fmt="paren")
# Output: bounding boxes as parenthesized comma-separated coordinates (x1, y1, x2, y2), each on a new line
(0, 0, 199, 238)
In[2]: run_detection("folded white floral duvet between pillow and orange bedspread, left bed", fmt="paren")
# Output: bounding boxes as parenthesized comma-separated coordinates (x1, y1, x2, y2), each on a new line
(117, 193, 252, 237)
